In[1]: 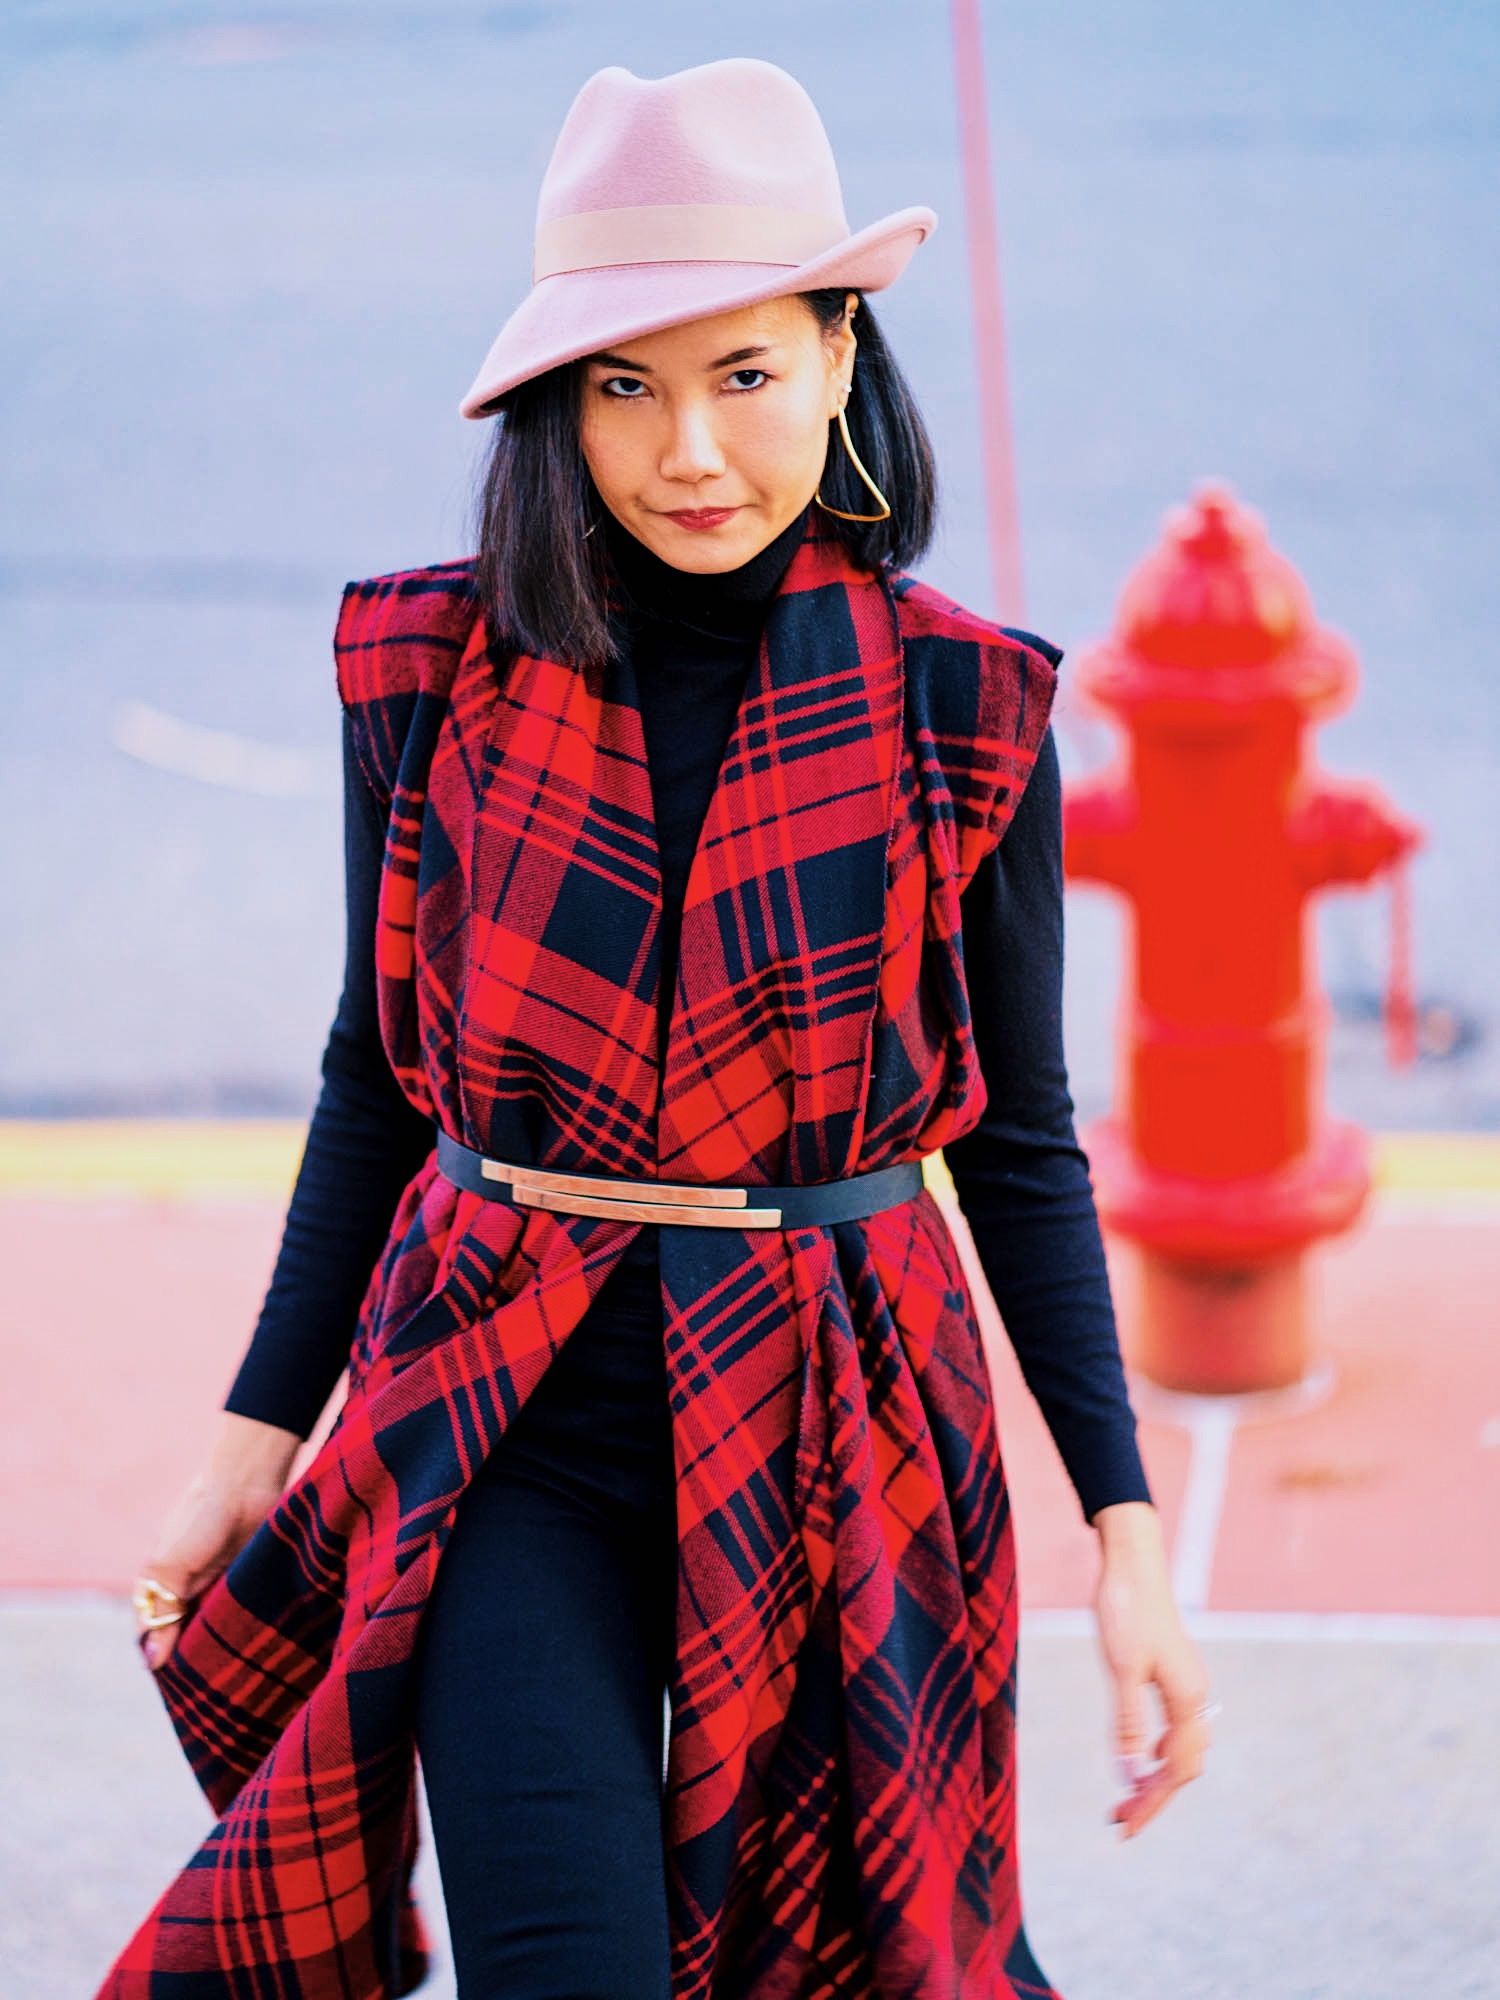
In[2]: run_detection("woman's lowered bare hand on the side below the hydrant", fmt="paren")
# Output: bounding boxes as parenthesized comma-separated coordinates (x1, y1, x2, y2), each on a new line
(1090, 1500, 1212, 1840)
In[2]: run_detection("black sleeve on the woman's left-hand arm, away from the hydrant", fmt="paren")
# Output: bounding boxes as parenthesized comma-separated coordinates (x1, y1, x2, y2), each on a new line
(224, 718, 434, 1438)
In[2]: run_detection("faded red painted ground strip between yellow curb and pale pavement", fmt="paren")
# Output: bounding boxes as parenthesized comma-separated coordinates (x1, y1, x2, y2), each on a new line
(0, 1196, 1500, 1614)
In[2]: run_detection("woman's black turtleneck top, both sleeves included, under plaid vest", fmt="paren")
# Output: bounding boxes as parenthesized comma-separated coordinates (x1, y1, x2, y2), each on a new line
(224, 516, 1152, 1518)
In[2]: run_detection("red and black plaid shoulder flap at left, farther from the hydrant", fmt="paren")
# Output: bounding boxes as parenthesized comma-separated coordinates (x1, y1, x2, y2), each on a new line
(334, 556, 478, 704)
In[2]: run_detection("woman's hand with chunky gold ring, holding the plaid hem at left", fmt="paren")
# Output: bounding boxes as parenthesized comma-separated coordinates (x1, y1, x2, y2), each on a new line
(136, 1410, 302, 1672)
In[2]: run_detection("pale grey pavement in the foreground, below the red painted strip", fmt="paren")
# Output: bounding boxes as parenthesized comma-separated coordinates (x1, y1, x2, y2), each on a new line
(0, 1592, 1500, 2000)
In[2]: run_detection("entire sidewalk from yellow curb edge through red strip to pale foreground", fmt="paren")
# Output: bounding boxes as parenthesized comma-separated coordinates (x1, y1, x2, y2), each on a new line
(0, 1124, 1500, 2000)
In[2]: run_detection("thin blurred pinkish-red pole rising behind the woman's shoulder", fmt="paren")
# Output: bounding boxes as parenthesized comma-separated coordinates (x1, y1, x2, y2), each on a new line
(952, 0, 1026, 624)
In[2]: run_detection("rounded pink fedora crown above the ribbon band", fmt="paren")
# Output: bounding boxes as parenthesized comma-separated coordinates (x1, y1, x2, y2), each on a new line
(536, 56, 848, 230)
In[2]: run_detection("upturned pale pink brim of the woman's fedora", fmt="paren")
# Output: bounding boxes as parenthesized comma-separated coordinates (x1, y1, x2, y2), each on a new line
(458, 208, 938, 416)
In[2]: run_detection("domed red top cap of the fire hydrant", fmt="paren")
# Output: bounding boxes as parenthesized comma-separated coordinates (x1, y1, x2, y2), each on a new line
(1116, 482, 1316, 668)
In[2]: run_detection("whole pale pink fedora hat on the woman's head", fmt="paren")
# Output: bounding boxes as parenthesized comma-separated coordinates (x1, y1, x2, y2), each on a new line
(458, 56, 938, 416)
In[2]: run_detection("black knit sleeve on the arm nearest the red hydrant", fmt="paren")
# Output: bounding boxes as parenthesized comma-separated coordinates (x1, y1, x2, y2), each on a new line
(944, 728, 1152, 1520)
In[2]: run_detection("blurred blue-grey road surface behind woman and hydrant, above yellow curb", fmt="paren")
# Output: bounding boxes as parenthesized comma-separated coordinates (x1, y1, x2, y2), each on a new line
(0, 0, 1500, 1128)
